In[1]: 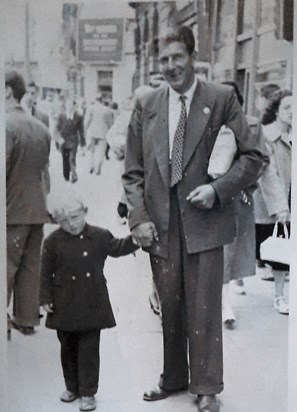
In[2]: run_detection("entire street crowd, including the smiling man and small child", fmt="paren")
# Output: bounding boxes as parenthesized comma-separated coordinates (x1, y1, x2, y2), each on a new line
(5, 26, 292, 412)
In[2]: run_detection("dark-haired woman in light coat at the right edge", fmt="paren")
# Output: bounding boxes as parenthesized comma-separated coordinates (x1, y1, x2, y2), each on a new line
(254, 90, 292, 314)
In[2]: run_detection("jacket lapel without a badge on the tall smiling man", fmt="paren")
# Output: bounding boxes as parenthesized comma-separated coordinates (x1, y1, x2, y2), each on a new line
(151, 87, 169, 186)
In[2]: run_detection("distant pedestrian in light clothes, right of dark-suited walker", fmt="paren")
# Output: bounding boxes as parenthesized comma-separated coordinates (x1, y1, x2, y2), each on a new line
(86, 96, 113, 175)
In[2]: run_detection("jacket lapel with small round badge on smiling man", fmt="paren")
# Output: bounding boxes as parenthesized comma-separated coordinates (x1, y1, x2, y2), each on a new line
(183, 81, 215, 169)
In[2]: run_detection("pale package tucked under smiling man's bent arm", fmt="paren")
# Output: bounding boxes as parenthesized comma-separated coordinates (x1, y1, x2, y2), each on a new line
(207, 126, 237, 179)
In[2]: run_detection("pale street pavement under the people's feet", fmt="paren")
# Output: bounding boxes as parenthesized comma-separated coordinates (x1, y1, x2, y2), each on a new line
(3, 148, 288, 412)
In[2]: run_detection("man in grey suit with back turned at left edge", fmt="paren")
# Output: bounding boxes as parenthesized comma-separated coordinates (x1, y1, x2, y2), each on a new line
(5, 70, 51, 337)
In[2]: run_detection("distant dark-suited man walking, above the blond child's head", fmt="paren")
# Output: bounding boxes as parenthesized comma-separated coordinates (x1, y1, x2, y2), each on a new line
(54, 97, 84, 183)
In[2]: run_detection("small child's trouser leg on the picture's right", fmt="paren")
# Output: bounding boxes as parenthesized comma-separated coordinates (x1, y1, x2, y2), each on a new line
(78, 330, 100, 396)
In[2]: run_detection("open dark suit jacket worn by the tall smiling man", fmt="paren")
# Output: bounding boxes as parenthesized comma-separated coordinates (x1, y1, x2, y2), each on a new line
(123, 81, 265, 257)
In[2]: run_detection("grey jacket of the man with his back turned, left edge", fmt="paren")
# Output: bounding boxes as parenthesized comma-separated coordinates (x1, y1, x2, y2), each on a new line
(6, 106, 51, 225)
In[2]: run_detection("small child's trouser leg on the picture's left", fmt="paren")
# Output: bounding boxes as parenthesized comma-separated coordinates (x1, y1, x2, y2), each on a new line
(57, 330, 79, 394)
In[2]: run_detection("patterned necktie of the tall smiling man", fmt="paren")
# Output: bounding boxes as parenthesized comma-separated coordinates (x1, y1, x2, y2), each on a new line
(170, 96, 187, 187)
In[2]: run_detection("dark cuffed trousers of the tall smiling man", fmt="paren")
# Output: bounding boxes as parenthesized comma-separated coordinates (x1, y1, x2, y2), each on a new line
(151, 188, 223, 395)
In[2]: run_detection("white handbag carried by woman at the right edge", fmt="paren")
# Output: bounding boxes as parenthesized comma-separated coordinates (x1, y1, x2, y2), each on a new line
(260, 222, 290, 265)
